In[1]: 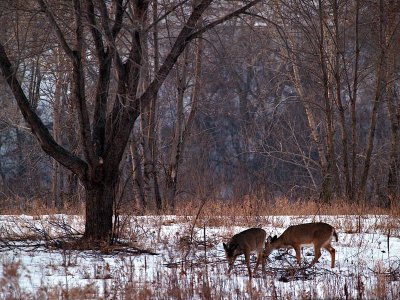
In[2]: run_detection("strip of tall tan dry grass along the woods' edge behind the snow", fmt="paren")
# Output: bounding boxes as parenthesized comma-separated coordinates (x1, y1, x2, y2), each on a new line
(0, 195, 400, 219)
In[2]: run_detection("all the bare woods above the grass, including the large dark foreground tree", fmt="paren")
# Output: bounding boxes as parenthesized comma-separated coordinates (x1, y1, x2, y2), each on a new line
(0, 0, 400, 240)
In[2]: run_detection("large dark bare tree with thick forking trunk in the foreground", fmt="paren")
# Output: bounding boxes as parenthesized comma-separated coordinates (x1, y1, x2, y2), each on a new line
(0, 0, 259, 246)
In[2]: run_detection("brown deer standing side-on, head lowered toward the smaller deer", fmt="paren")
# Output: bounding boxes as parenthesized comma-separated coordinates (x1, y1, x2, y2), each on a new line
(264, 222, 338, 268)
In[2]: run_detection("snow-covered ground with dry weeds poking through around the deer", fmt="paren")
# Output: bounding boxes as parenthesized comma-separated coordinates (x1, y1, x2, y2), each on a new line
(0, 215, 400, 299)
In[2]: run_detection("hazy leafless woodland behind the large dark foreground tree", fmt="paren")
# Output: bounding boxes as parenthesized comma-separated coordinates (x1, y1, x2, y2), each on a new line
(0, 0, 400, 212)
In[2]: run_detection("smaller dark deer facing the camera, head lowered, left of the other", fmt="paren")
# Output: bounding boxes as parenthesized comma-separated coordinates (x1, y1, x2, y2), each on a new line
(223, 228, 267, 278)
